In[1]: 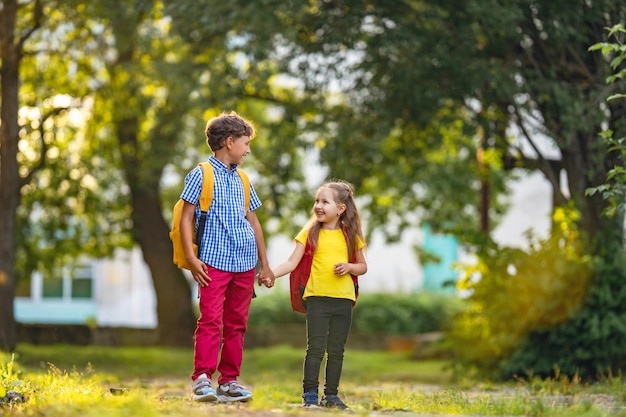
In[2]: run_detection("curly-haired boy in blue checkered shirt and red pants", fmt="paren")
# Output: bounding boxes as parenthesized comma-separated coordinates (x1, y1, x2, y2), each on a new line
(180, 112, 273, 402)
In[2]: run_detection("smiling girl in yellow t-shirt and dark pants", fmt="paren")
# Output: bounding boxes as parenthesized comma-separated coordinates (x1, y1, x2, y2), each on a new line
(272, 180, 367, 409)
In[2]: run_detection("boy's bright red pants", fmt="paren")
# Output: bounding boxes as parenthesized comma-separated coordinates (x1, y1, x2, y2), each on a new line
(191, 266, 255, 384)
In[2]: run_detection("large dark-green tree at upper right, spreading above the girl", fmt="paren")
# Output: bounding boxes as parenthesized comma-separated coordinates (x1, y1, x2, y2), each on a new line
(250, 0, 624, 241)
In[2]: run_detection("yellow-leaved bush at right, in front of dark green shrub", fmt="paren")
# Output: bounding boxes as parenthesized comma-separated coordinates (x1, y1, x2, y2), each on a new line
(451, 206, 592, 377)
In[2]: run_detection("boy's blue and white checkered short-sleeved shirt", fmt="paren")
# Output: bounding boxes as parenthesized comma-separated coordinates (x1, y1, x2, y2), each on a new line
(180, 156, 261, 272)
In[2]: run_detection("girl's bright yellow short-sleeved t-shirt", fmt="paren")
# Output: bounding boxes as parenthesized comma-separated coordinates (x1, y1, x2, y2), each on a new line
(295, 229, 365, 301)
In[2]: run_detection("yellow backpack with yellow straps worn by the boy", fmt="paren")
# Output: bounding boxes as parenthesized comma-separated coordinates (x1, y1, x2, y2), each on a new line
(170, 162, 250, 269)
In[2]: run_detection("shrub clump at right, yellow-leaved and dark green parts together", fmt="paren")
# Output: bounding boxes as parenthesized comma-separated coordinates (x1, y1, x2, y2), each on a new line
(450, 209, 626, 379)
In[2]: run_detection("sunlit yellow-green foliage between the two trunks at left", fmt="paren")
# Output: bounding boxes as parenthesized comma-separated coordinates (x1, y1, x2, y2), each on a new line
(15, 2, 131, 283)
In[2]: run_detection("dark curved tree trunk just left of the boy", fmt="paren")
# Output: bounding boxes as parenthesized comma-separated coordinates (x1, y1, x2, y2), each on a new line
(102, 2, 195, 346)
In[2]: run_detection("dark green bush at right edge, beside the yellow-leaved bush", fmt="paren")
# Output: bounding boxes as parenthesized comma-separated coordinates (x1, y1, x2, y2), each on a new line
(500, 231, 626, 380)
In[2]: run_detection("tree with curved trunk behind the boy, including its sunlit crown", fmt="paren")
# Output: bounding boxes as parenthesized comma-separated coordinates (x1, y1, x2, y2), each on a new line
(64, 1, 312, 344)
